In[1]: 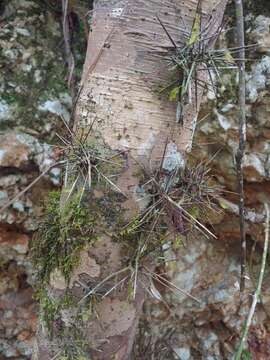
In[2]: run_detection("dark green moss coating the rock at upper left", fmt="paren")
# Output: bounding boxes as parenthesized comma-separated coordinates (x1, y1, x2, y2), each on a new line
(0, 0, 71, 142)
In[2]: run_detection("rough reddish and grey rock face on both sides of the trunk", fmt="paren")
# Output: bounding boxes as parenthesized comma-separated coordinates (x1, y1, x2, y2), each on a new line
(0, 0, 270, 360)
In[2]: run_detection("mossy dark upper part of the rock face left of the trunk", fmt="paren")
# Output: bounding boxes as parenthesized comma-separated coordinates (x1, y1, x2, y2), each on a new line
(0, 1, 71, 139)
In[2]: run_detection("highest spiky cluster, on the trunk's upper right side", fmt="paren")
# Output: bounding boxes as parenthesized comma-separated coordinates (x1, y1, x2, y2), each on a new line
(157, 1, 251, 122)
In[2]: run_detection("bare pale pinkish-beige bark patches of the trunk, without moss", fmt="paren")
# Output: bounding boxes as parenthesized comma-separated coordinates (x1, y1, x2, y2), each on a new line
(33, 0, 227, 360)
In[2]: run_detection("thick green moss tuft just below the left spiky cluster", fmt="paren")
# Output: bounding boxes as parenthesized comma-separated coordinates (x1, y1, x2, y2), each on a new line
(31, 191, 96, 286)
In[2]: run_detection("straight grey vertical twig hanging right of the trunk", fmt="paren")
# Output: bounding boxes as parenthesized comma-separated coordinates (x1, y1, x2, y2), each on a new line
(235, 0, 247, 292)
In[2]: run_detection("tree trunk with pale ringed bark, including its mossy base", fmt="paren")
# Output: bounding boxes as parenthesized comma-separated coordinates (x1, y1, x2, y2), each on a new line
(34, 0, 227, 360)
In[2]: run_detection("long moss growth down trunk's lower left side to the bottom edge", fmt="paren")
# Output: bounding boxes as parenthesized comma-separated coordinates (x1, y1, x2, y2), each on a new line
(31, 191, 98, 352)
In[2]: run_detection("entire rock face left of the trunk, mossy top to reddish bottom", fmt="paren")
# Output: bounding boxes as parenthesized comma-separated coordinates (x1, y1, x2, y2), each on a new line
(0, 0, 71, 359)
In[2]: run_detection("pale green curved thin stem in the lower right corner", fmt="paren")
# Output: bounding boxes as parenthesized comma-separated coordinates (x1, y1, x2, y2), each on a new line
(234, 204, 270, 360)
